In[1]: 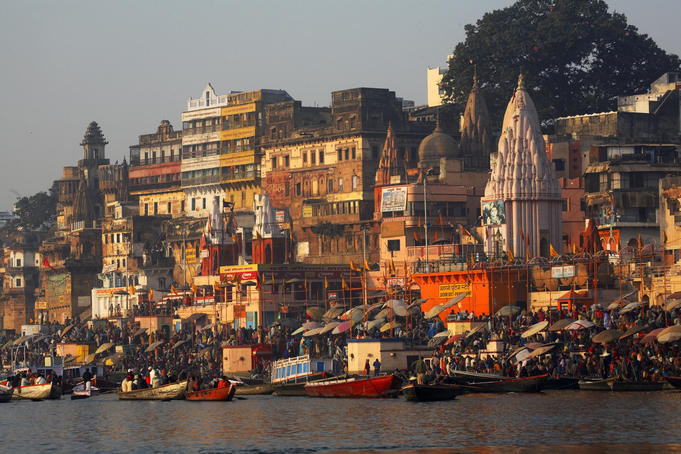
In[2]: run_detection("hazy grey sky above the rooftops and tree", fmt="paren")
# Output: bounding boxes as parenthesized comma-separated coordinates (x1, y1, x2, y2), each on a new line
(0, 0, 681, 211)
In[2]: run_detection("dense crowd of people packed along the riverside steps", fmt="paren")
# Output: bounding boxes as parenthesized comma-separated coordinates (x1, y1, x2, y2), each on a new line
(0, 294, 681, 387)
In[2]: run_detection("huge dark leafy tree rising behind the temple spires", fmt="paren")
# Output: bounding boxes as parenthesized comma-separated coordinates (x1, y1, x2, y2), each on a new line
(442, 0, 681, 128)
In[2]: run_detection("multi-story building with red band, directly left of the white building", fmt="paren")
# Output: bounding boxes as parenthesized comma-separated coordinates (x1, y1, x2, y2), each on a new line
(129, 120, 185, 216)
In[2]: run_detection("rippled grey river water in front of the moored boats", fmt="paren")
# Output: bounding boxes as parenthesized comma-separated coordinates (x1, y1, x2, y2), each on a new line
(0, 391, 681, 454)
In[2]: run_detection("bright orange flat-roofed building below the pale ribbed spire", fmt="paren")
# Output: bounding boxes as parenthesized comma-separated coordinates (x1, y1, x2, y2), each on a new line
(412, 267, 527, 320)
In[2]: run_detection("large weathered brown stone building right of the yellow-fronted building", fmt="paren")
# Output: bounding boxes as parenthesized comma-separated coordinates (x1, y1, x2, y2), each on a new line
(262, 88, 425, 263)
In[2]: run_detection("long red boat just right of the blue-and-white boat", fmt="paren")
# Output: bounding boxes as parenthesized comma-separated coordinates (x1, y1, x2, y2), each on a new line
(305, 374, 400, 397)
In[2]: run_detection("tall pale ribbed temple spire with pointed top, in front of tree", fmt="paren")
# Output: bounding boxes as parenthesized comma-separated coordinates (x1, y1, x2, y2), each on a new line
(483, 75, 562, 258)
